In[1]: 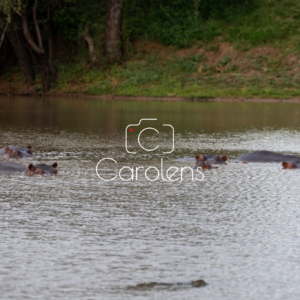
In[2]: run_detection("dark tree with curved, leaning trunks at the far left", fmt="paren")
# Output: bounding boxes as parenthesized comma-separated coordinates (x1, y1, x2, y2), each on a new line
(0, 0, 58, 93)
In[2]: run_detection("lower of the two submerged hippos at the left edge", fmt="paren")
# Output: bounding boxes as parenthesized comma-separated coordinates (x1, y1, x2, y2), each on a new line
(0, 161, 57, 175)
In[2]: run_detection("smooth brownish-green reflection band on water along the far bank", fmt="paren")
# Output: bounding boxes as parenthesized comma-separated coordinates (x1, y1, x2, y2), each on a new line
(0, 97, 300, 134)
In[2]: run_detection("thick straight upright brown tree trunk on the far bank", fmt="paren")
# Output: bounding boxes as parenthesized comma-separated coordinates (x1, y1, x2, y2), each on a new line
(106, 0, 123, 63)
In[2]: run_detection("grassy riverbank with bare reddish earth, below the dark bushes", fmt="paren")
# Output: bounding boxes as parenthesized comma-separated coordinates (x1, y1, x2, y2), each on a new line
(0, 41, 300, 98)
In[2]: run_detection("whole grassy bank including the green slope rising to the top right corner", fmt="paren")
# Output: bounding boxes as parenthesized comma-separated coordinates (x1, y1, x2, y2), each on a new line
(0, 0, 300, 98)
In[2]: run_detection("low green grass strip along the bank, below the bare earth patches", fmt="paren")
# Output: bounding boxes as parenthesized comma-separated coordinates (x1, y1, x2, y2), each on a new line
(57, 50, 300, 98)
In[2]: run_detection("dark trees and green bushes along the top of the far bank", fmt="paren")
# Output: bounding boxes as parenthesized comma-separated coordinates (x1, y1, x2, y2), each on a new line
(0, 0, 257, 92)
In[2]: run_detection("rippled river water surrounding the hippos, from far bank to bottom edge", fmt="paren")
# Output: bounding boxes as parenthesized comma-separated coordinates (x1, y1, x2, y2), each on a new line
(0, 97, 300, 300)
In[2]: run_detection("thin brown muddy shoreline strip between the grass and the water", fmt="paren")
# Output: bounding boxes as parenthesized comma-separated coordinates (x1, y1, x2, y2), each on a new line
(0, 92, 300, 103)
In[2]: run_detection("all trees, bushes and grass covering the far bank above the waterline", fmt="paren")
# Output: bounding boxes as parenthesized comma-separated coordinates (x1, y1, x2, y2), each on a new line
(0, 0, 300, 97)
